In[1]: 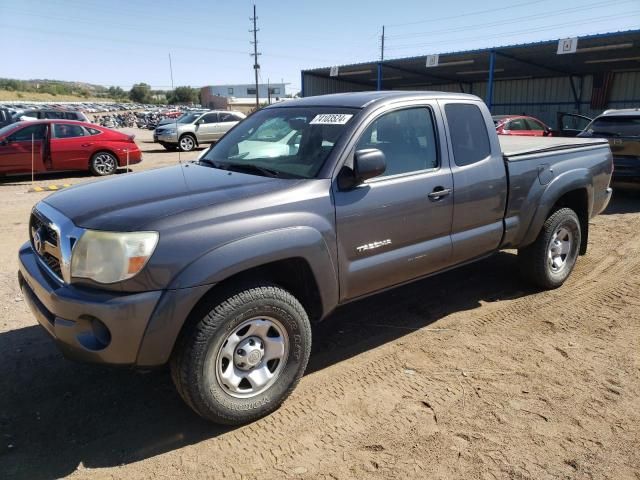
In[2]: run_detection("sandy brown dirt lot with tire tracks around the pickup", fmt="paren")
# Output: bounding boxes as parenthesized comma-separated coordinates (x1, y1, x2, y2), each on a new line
(0, 131, 640, 480)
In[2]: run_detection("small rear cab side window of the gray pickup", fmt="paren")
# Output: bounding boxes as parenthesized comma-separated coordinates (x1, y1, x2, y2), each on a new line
(444, 103, 491, 167)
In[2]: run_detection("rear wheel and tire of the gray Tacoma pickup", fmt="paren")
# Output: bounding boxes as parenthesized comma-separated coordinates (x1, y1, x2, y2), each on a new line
(518, 208, 582, 290)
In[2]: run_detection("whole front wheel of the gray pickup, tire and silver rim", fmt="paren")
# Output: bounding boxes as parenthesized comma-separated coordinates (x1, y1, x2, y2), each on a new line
(171, 285, 311, 425)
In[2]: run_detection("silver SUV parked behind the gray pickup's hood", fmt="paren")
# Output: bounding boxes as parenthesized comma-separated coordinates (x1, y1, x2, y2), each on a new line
(153, 110, 245, 152)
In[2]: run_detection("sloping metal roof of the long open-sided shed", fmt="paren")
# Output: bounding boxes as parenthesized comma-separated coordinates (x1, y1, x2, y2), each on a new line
(302, 30, 640, 89)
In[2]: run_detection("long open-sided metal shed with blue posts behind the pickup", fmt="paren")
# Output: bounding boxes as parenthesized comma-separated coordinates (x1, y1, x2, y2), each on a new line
(301, 30, 640, 126)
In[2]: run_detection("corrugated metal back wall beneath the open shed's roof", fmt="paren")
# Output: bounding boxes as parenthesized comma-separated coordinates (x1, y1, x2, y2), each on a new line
(304, 72, 640, 127)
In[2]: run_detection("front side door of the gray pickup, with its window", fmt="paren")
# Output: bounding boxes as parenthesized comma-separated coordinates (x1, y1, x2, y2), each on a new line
(332, 104, 453, 300)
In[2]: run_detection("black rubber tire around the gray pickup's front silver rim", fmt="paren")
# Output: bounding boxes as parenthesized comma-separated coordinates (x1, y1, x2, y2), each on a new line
(170, 284, 311, 425)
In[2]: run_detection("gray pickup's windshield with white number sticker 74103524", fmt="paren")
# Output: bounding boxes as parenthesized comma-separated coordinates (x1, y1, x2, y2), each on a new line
(200, 107, 358, 178)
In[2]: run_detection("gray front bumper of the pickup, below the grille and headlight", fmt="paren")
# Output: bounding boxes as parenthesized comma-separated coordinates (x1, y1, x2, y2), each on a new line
(18, 243, 163, 365)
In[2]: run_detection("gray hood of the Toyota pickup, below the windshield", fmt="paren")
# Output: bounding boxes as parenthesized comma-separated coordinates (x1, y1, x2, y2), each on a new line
(44, 163, 299, 231)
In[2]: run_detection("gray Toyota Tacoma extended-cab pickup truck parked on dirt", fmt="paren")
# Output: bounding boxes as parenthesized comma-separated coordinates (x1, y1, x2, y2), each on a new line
(19, 92, 612, 424)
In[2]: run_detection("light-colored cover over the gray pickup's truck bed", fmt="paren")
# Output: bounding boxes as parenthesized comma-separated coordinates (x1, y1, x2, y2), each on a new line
(498, 135, 608, 161)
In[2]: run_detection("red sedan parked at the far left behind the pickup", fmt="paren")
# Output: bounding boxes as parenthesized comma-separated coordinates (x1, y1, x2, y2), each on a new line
(0, 120, 142, 176)
